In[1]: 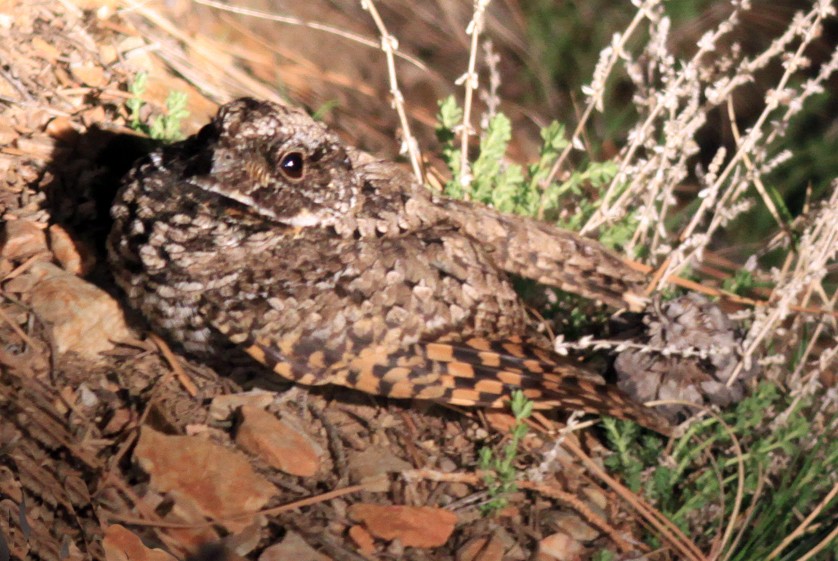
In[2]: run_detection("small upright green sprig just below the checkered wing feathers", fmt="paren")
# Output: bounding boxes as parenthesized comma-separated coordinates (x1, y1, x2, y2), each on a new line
(478, 390, 533, 514)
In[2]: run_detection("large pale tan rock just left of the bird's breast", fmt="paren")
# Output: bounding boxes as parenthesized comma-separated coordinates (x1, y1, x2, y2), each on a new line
(15, 263, 132, 361)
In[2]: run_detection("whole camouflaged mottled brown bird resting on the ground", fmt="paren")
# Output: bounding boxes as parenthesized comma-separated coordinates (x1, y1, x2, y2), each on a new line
(108, 99, 666, 431)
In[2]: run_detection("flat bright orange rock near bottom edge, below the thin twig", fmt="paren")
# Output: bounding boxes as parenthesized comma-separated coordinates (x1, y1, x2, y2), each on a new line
(349, 503, 457, 548)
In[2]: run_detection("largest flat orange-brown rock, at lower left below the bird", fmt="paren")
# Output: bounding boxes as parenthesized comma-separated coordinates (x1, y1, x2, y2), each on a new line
(134, 427, 276, 531)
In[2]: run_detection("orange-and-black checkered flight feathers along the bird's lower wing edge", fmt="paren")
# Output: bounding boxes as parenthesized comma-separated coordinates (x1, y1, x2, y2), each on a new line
(240, 332, 670, 434)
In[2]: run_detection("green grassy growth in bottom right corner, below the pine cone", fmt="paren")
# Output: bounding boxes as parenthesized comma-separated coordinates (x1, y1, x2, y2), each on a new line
(603, 382, 838, 561)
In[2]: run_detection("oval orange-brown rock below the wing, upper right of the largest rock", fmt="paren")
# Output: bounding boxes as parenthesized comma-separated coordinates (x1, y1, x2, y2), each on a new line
(236, 405, 320, 477)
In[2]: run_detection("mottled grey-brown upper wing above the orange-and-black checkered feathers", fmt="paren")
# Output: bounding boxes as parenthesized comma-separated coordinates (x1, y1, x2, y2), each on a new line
(200, 223, 525, 384)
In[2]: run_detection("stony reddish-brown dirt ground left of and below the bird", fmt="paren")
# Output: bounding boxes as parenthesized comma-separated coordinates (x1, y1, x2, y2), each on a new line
(0, 0, 704, 561)
